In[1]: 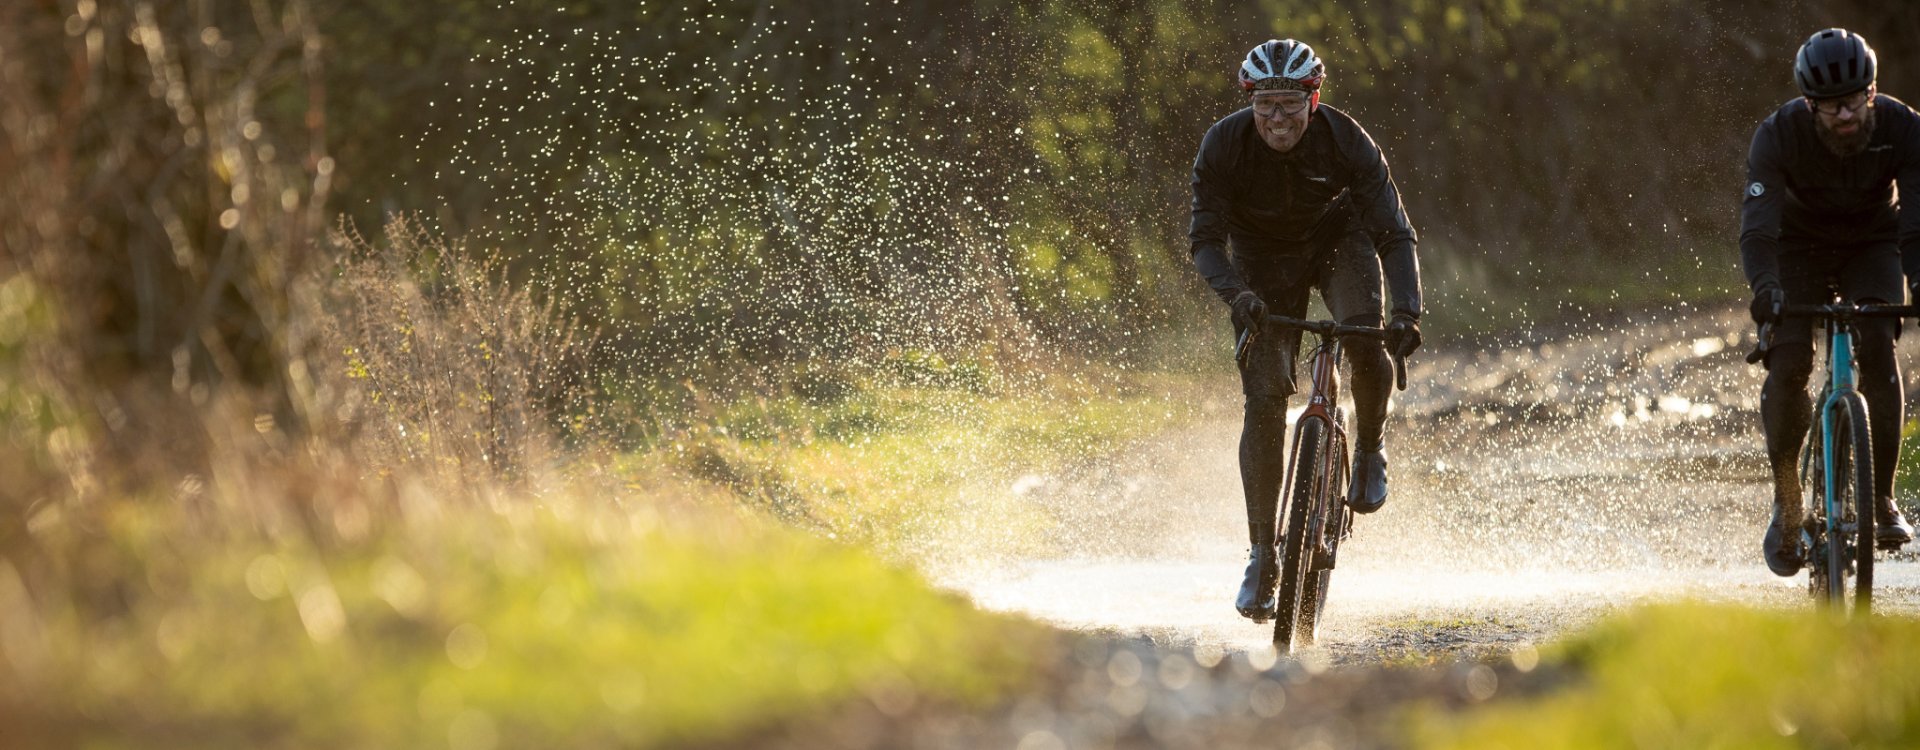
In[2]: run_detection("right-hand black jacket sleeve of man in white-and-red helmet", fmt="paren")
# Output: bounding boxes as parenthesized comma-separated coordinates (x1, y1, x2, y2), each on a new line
(1340, 123, 1421, 318)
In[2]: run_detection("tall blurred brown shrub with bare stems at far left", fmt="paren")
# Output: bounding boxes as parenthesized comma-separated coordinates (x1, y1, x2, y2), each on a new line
(0, 0, 334, 435)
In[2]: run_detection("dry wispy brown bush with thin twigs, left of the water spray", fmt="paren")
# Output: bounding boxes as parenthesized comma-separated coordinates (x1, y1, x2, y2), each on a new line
(315, 219, 593, 476)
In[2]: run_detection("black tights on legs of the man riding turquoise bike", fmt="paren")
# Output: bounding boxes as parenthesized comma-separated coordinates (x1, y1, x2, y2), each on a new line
(1761, 318, 1905, 503)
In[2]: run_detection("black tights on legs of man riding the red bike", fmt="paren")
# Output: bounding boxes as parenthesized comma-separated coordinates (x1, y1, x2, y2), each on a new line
(1240, 335, 1394, 547)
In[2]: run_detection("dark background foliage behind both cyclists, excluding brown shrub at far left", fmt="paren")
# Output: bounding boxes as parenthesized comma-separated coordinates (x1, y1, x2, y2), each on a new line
(299, 0, 1920, 386)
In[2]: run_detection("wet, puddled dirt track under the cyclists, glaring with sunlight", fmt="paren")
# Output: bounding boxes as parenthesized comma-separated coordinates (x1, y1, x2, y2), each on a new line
(821, 311, 1920, 748)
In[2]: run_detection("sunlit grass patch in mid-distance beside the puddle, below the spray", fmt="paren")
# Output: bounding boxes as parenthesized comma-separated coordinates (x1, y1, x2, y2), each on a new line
(652, 372, 1198, 556)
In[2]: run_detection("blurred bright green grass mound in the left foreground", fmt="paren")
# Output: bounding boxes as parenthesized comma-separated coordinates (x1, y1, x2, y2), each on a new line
(0, 499, 1050, 748)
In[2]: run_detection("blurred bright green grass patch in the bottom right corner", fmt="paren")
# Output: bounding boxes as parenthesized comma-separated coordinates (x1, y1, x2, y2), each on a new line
(1415, 604, 1920, 748)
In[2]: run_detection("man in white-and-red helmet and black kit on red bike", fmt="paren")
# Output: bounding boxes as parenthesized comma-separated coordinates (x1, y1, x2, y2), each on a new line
(1188, 38, 1421, 620)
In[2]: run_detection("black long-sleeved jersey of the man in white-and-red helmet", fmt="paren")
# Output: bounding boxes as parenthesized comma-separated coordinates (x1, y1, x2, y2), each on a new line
(1187, 104, 1421, 315)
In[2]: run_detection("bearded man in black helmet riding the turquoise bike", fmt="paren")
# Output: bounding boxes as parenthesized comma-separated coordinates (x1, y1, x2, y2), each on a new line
(1740, 29, 1920, 575)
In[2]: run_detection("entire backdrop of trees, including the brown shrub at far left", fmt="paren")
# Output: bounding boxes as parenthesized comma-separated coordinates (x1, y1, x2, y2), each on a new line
(0, 0, 1920, 469)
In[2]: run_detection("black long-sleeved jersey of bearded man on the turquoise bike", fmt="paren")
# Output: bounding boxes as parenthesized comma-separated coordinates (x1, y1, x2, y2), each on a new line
(1740, 94, 1920, 291)
